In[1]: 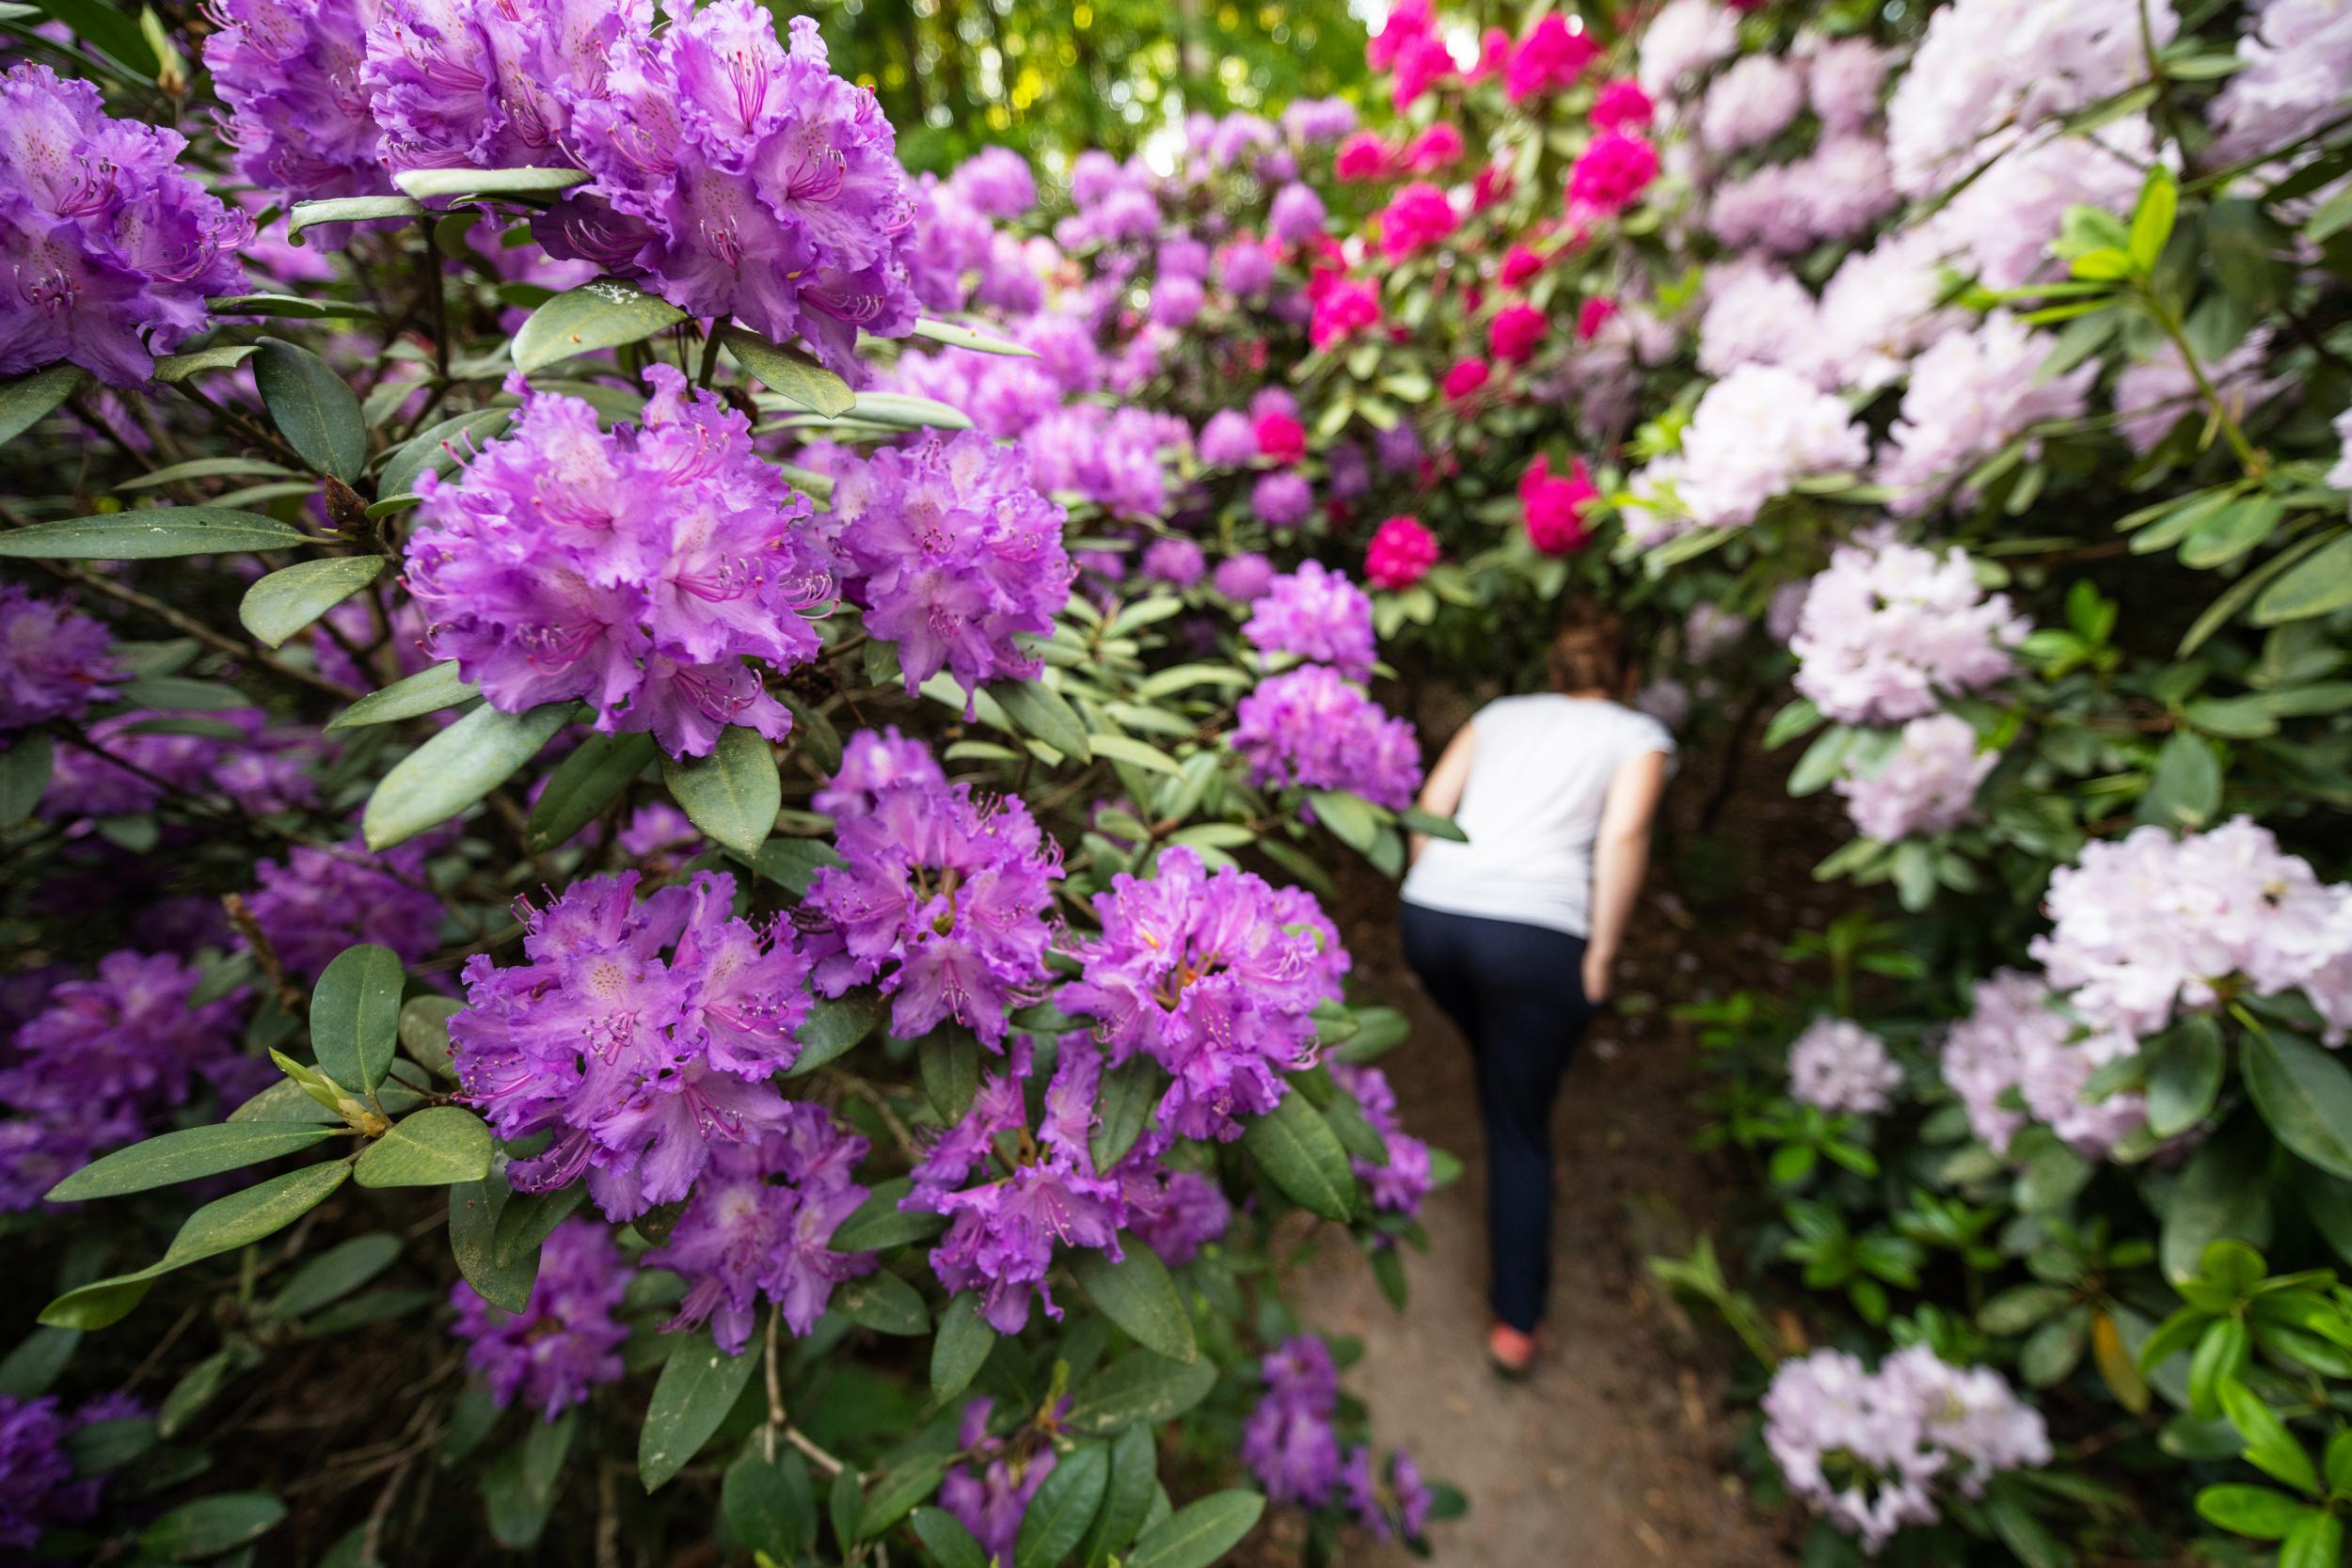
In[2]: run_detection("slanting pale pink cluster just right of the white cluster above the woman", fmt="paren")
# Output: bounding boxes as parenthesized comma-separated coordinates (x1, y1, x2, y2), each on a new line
(1880, 310, 2098, 515)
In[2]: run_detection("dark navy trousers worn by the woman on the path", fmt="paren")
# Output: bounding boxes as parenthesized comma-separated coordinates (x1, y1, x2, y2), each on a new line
(1402, 905, 1593, 1333)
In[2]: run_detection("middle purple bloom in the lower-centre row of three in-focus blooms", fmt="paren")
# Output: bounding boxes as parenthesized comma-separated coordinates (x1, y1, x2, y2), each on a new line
(807, 736, 1061, 1046)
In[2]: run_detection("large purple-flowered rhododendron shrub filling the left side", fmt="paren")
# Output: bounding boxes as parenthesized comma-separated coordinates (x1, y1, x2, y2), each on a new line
(0, 0, 1458, 1566)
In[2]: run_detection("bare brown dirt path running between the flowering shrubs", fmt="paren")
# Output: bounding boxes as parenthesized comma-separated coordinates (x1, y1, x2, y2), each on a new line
(1294, 728, 1811, 1568)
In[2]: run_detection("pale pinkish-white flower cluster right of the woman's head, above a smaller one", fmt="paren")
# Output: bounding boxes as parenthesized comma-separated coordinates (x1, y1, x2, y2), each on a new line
(1790, 529, 2032, 724)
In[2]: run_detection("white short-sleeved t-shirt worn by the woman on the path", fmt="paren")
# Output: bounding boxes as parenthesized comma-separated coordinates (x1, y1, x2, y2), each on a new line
(1405, 693, 1675, 936)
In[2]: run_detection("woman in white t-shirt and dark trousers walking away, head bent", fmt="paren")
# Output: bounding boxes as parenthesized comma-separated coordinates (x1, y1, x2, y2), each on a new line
(1405, 609, 1675, 1373)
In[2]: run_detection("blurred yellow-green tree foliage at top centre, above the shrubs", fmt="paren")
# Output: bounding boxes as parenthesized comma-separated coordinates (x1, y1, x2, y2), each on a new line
(814, 0, 1388, 171)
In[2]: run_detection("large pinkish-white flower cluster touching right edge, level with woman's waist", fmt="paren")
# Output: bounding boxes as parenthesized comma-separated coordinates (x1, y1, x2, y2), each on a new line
(2032, 816, 2352, 1044)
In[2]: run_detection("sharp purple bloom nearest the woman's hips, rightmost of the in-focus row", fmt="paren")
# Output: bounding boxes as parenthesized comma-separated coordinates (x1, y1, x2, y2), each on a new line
(1061, 847, 1348, 1143)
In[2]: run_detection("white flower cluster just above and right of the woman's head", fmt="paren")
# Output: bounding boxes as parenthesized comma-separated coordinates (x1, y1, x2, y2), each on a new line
(1626, 364, 1870, 546)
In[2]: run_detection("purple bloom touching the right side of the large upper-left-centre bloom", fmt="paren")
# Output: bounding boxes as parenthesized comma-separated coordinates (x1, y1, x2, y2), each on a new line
(826, 430, 1073, 693)
